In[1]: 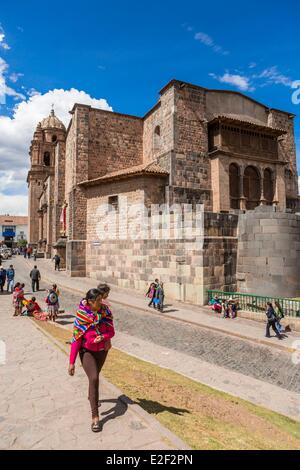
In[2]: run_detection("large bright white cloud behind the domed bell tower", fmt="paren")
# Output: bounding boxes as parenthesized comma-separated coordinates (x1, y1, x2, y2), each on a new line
(0, 87, 112, 215)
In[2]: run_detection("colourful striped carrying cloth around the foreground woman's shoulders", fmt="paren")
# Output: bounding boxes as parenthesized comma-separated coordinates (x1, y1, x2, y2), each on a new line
(72, 300, 113, 343)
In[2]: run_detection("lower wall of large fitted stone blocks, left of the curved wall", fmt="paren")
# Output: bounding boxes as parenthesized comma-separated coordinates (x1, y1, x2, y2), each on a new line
(86, 212, 237, 305)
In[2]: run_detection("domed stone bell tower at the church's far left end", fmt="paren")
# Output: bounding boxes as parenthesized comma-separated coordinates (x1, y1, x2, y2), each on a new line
(27, 109, 66, 245)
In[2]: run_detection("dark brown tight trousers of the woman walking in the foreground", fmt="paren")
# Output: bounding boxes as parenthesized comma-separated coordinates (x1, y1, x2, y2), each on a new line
(79, 349, 108, 418)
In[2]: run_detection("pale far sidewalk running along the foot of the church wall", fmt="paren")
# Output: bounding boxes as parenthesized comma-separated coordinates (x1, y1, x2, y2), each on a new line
(22, 258, 300, 352)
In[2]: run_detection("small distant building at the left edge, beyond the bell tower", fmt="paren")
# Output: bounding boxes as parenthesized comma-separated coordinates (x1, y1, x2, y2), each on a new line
(0, 215, 28, 247)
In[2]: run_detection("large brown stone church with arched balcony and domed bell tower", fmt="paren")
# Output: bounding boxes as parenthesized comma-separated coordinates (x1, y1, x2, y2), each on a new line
(27, 80, 300, 304)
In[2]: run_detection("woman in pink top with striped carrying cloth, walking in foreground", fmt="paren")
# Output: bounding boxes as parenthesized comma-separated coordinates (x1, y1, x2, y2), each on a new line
(69, 289, 115, 432)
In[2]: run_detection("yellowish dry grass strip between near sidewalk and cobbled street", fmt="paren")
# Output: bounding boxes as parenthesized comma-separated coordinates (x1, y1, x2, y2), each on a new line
(34, 322, 300, 450)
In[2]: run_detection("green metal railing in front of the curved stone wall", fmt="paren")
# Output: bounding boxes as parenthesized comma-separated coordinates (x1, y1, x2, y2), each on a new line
(207, 290, 300, 317)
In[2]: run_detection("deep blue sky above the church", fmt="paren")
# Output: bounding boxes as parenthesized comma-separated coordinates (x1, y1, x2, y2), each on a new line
(0, 0, 300, 213)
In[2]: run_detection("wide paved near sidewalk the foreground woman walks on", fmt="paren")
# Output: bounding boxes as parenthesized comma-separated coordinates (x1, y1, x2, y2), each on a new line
(0, 295, 188, 450)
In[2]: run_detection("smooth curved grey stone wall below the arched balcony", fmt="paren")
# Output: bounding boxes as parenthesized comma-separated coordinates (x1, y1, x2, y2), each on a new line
(237, 206, 300, 297)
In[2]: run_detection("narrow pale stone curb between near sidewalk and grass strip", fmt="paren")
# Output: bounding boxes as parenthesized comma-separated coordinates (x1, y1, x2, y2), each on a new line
(30, 318, 191, 450)
